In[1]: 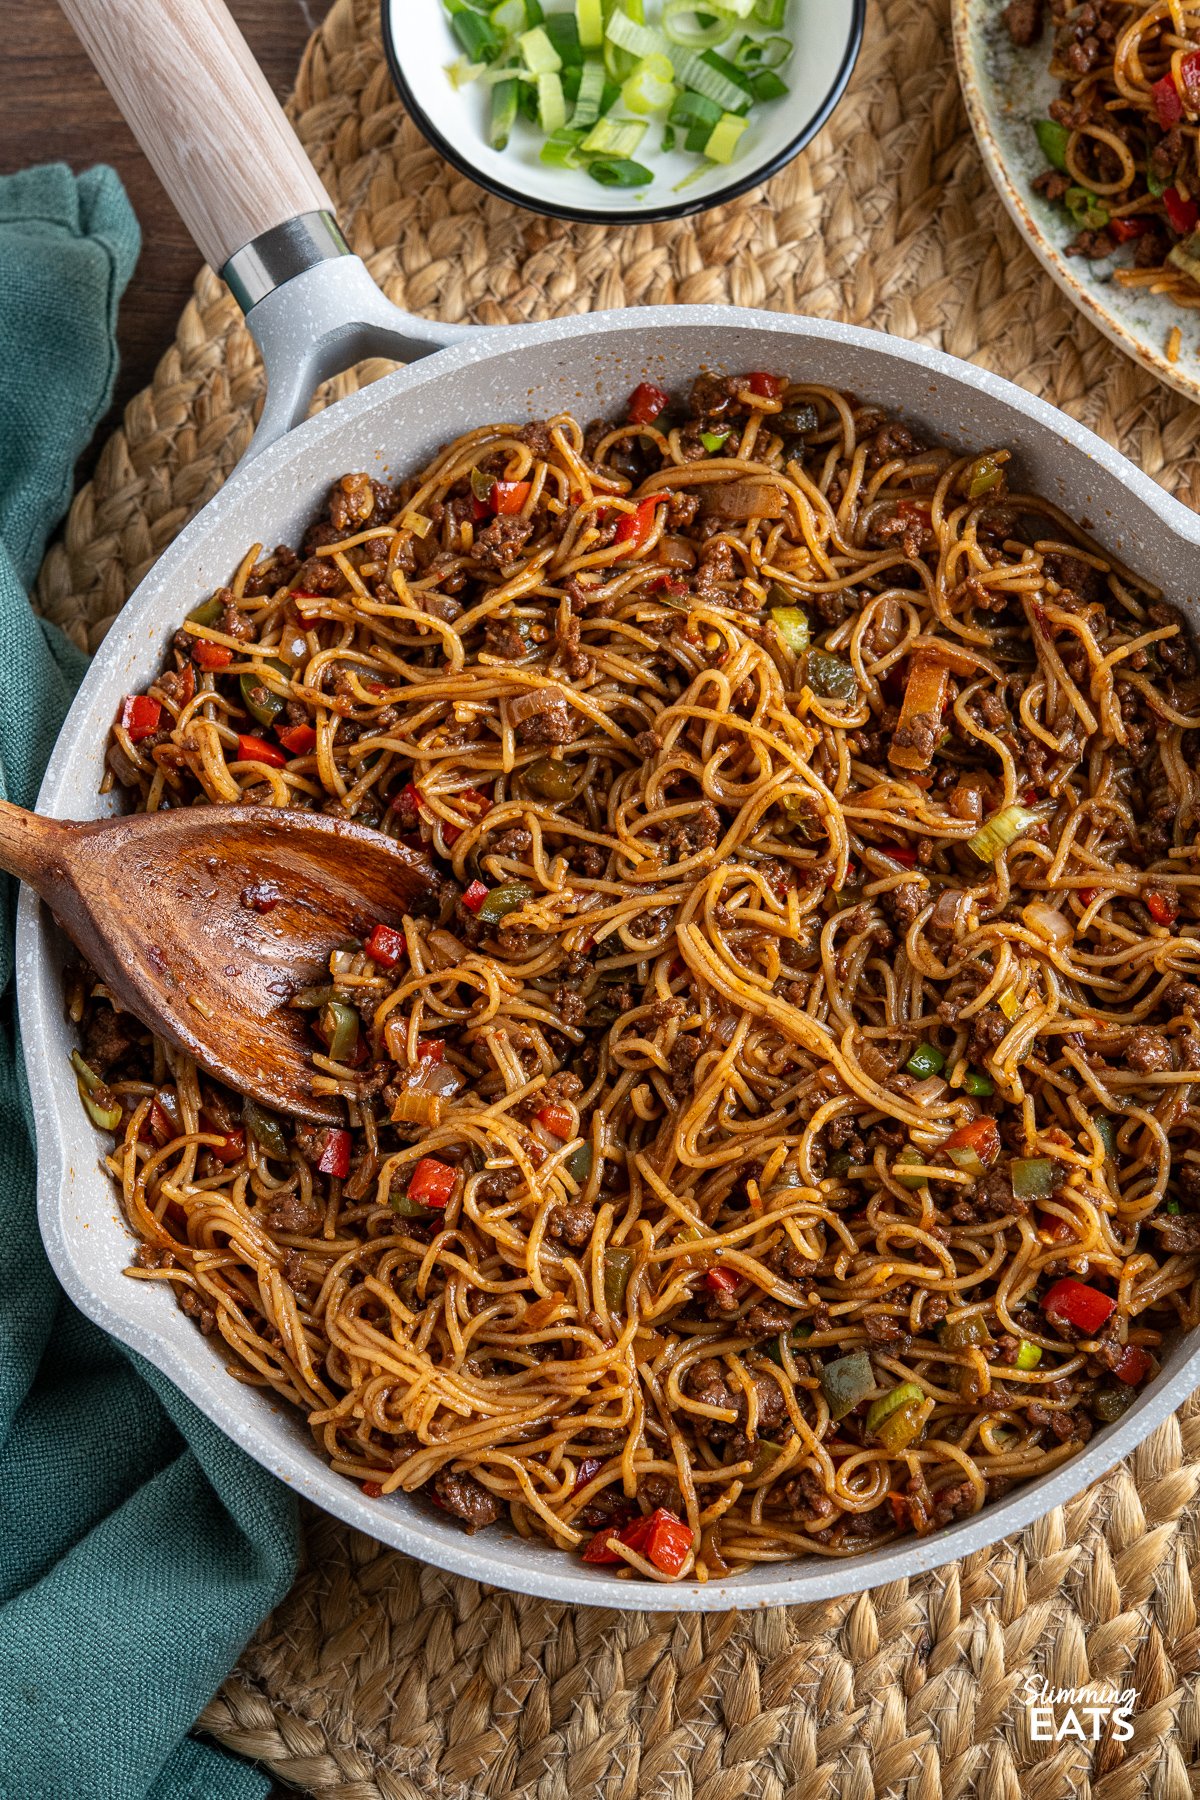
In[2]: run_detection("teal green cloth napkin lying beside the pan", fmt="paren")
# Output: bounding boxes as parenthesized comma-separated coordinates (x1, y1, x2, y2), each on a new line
(0, 167, 297, 1800)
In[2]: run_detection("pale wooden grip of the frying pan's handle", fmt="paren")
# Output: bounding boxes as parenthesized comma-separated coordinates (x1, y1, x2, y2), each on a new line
(59, 0, 333, 270)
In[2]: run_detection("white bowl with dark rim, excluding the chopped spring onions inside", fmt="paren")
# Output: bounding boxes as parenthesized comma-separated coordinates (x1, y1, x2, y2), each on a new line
(383, 0, 867, 225)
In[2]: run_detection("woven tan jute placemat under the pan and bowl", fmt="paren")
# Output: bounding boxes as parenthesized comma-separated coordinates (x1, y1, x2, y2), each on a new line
(40, 0, 1200, 1800)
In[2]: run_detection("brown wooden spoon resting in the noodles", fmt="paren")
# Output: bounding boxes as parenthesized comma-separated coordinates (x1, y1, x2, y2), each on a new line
(0, 801, 437, 1123)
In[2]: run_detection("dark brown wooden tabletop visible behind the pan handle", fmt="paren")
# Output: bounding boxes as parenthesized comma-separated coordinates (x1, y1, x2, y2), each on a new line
(0, 0, 329, 475)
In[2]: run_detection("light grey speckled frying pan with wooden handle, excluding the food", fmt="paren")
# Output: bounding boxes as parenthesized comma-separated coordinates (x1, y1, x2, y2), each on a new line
(18, 0, 1200, 1611)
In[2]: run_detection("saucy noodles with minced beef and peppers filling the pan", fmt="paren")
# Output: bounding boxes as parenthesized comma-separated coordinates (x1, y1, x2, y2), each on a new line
(70, 374, 1200, 1580)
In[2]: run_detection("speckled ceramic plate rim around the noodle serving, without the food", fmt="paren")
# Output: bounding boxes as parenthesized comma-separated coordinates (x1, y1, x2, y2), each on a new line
(952, 0, 1200, 401)
